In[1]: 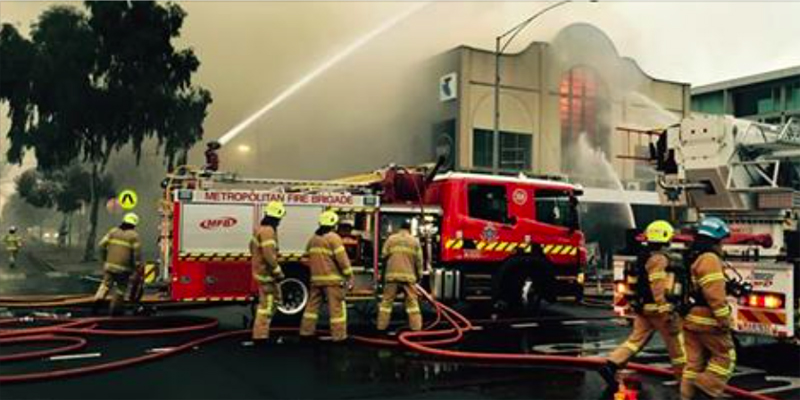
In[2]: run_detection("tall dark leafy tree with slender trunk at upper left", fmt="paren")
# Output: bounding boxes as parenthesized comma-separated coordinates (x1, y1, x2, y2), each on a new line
(0, 1, 211, 258)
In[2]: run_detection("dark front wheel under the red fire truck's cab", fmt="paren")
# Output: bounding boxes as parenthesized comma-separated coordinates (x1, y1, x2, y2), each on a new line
(497, 256, 552, 314)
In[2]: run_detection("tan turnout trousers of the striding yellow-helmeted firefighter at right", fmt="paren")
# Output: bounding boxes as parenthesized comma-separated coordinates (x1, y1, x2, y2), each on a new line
(608, 314, 687, 381)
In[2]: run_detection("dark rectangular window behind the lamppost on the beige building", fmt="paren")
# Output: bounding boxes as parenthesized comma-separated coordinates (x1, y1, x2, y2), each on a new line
(472, 129, 533, 171)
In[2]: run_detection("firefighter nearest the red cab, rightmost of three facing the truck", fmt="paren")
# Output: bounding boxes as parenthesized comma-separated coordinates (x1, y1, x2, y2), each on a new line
(378, 221, 423, 331)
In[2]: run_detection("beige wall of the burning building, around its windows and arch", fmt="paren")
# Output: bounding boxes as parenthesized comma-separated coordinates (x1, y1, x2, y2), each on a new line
(448, 24, 688, 186)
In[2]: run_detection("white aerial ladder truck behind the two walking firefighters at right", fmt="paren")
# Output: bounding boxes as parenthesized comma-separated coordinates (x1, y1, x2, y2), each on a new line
(614, 115, 800, 338)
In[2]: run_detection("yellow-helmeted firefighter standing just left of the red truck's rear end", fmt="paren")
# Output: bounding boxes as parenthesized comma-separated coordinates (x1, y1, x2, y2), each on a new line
(92, 213, 142, 315)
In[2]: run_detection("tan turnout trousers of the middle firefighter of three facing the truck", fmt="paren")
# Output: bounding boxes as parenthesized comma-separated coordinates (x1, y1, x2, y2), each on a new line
(300, 285, 347, 342)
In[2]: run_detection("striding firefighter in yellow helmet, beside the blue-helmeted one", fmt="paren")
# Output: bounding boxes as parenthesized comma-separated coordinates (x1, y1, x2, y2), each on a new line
(600, 220, 686, 390)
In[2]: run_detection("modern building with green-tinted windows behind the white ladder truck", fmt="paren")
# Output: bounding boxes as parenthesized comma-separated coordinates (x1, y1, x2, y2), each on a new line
(692, 66, 800, 124)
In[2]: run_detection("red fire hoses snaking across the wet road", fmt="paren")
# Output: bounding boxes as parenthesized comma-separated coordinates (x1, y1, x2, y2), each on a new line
(0, 286, 774, 400)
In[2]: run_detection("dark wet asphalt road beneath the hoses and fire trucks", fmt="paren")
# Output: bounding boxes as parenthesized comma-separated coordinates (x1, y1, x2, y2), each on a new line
(0, 252, 800, 399)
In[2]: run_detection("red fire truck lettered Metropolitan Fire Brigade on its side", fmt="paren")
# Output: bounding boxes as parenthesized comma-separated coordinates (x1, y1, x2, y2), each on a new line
(160, 166, 586, 314)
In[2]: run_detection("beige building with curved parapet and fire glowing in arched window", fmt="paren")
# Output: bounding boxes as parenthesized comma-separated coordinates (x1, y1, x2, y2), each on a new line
(434, 24, 690, 190)
